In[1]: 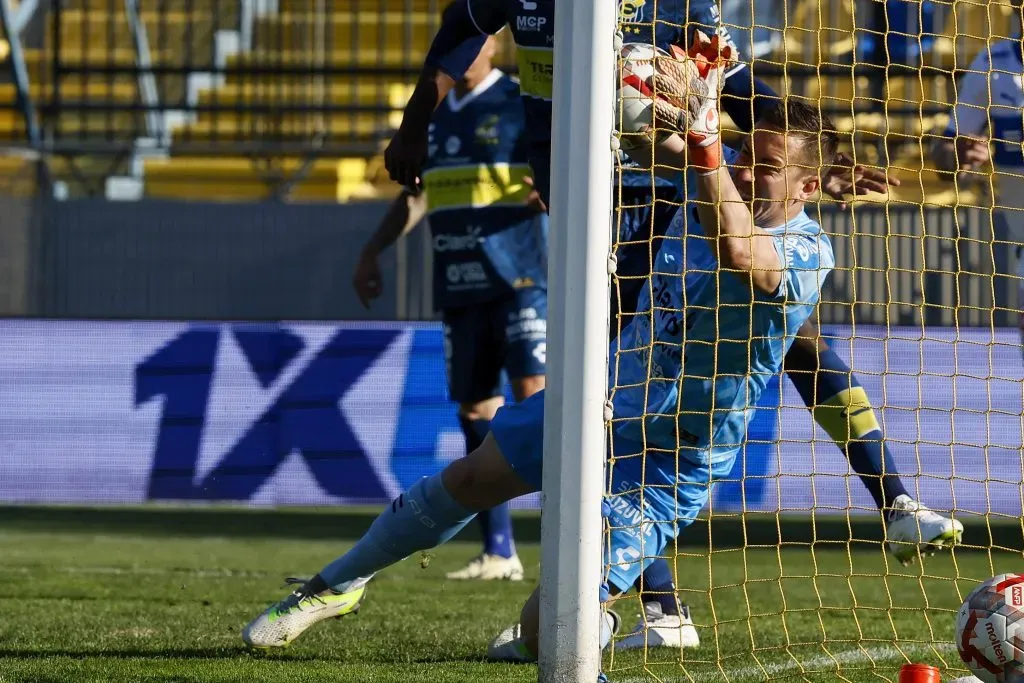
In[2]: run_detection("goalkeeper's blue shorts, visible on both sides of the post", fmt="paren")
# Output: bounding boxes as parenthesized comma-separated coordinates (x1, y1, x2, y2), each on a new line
(490, 391, 735, 591)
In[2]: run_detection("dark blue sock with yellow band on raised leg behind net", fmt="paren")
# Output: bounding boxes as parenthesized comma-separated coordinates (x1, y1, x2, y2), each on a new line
(785, 340, 907, 509)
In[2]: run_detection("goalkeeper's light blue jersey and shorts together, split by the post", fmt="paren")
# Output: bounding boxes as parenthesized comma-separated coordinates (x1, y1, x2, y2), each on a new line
(490, 158, 835, 591)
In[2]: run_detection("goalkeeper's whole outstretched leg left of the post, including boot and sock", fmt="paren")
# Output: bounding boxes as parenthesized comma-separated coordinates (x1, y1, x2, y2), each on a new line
(242, 391, 544, 647)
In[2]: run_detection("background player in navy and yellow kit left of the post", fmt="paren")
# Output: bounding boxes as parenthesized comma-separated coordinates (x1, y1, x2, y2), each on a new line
(353, 40, 548, 581)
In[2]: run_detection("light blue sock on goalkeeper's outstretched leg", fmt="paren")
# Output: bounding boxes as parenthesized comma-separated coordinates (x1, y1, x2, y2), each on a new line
(319, 473, 476, 586)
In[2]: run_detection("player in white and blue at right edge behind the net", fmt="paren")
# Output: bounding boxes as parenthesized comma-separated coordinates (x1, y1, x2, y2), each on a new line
(932, 38, 1024, 353)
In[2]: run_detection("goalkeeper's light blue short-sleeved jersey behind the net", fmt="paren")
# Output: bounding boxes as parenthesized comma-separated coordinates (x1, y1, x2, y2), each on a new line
(609, 200, 835, 464)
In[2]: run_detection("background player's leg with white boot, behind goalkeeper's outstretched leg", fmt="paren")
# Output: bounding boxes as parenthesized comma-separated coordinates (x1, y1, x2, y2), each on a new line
(445, 296, 528, 581)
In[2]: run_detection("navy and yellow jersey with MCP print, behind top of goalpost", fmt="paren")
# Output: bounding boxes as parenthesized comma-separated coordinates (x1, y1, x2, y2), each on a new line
(468, 0, 741, 200)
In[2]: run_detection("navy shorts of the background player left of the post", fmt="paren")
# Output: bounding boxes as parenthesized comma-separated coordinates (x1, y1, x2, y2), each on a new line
(441, 288, 548, 403)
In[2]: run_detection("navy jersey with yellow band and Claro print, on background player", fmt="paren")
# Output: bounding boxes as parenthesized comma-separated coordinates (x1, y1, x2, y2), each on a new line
(423, 69, 548, 309)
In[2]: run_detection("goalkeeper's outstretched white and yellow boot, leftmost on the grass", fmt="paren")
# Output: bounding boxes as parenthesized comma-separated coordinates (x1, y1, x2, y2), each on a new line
(242, 579, 368, 648)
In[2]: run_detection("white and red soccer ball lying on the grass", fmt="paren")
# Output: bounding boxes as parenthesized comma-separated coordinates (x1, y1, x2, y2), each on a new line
(956, 573, 1024, 683)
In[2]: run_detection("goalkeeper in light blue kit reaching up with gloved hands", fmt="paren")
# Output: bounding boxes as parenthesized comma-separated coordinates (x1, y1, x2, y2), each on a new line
(243, 34, 837, 658)
